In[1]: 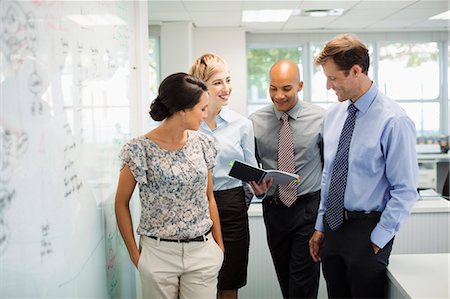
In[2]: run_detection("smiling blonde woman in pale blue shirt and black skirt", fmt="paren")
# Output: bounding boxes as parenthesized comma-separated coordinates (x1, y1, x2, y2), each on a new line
(190, 53, 257, 299)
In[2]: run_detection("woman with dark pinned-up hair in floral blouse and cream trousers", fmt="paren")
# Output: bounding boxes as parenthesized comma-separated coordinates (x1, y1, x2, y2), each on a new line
(115, 73, 224, 298)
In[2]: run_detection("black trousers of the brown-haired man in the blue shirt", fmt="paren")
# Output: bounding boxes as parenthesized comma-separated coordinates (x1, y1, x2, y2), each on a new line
(320, 218, 394, 298)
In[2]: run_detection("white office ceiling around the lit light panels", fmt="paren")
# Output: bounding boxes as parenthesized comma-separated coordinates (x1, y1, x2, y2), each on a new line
(147, 0, 449, 32)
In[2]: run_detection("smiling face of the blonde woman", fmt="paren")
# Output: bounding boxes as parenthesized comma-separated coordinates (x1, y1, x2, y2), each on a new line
(206, 69, 233, 110)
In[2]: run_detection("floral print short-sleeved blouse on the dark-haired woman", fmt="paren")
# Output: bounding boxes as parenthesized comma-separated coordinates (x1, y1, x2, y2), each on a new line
(120, 131, 217, 239)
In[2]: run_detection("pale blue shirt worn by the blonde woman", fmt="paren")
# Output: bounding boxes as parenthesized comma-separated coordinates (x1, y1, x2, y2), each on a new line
(200, 107, 257, 191)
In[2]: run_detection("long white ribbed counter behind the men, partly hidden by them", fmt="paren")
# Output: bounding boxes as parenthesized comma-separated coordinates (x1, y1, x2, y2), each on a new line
(243, 197, 450, 299)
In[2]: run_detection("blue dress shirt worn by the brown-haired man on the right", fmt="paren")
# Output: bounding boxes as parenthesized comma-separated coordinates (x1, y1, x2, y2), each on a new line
(316, 83, 419, 248)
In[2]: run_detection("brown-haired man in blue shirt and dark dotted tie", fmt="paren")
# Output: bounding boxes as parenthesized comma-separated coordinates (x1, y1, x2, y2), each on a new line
(309, 34, 418, 298)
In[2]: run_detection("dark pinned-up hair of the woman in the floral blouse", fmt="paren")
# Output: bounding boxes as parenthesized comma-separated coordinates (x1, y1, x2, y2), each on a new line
(149, 73, 208, 121)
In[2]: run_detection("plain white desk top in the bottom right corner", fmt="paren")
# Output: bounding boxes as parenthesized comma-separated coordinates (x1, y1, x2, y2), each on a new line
(387, 253, 450, 298)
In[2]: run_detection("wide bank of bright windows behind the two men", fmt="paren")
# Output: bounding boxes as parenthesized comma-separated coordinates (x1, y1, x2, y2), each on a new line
(247, 32, 450, 137)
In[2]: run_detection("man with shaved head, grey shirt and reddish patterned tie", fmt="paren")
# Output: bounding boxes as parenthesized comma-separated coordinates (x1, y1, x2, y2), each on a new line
(250, 60, 325, 298)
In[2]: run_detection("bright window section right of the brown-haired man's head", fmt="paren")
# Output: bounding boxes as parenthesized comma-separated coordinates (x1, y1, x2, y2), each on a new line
(378, 42, 440, 136)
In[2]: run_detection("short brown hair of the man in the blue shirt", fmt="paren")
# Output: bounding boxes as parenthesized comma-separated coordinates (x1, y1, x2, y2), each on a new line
(314, 33, 370, 75)
